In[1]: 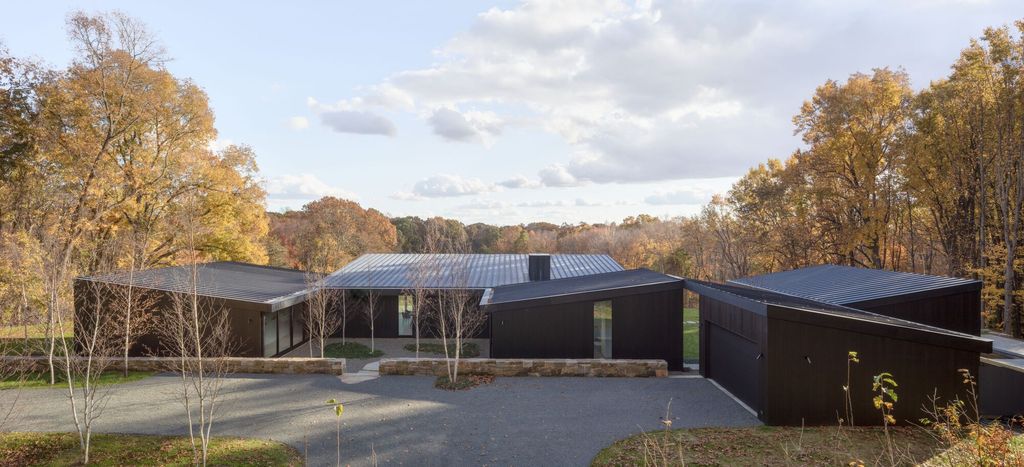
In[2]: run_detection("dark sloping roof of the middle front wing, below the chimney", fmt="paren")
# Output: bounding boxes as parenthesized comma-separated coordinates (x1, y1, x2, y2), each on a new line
(480, 268, 683, 310)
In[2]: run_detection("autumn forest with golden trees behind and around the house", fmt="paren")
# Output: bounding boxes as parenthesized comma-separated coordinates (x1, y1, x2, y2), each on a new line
(0, 13, 1024, 335)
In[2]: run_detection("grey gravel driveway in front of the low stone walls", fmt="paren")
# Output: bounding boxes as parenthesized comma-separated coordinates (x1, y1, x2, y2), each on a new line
(0, 375, 758, 465)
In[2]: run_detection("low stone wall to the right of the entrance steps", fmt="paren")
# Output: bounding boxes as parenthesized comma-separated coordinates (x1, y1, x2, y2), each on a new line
(379, 358, 669, 378)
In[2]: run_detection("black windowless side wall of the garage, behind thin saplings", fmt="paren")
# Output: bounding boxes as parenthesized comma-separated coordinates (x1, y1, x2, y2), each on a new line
(762, 307, 978, 425)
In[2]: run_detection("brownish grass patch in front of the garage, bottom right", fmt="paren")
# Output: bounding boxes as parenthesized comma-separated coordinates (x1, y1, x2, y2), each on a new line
(593, 426, 940, 466)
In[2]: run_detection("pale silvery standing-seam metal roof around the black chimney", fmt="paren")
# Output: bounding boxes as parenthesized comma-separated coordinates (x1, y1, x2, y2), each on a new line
(325, 253, 623, 289)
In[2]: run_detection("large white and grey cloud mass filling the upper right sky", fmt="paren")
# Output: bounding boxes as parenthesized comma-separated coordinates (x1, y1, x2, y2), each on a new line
(315, 0, 1012, 183)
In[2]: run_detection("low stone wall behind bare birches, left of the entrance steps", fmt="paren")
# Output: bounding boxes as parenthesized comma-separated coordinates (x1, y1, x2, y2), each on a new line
(3, 356, 345, 375)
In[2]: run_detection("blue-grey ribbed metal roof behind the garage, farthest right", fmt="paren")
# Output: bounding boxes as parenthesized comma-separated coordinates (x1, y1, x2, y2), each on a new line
(729, 264, 981, 305)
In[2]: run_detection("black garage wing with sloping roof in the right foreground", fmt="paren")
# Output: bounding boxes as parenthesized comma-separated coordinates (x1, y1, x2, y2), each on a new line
(686, 280, 992, 425)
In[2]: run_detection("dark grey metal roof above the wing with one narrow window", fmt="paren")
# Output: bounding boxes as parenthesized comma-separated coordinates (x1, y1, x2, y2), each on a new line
(480, 268, 683, 305)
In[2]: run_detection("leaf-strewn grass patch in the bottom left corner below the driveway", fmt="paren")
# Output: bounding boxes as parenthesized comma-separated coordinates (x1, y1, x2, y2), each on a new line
(0, 433, 302, 466)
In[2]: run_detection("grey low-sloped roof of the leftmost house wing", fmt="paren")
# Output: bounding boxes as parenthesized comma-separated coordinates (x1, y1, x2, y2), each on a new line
(79, 261, 306, 310)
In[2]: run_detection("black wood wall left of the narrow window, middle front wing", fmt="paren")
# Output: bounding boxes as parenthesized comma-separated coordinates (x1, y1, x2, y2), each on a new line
(490, 301, 593, 358)
